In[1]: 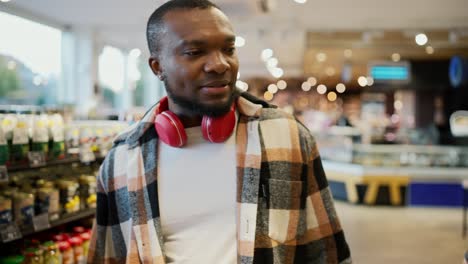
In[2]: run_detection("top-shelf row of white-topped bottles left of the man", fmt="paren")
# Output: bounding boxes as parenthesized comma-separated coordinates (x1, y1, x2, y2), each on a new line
(0, 106, 127, 166)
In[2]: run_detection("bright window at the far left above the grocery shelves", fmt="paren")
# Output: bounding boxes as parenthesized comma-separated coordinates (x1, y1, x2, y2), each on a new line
(0, 12, 62, 105)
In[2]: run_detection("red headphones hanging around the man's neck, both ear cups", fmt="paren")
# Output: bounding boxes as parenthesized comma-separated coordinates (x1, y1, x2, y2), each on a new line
(154, 97, 236, 147)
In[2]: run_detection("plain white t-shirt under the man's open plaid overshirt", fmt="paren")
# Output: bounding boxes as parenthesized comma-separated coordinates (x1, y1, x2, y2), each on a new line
(158, 124, 237, 264)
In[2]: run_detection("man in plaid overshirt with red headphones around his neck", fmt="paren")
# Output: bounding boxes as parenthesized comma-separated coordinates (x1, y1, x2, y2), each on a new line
(89, 0, 351, 264)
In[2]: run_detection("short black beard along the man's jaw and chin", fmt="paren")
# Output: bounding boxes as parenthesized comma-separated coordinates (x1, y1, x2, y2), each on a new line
(164, 80, 239, 117)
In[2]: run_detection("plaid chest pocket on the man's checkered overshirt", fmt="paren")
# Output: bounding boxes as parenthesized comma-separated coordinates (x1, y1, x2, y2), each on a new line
(268, 179, 307, 243)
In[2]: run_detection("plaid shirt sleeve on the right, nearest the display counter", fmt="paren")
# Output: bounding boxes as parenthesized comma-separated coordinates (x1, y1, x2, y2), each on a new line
(295, 124, 351, 263)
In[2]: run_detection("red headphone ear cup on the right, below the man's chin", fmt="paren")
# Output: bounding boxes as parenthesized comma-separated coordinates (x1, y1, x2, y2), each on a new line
(201, 107, 236, 143)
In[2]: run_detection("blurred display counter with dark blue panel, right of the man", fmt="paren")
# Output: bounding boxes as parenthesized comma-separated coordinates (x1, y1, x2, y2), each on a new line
(317, 130, 468, 206)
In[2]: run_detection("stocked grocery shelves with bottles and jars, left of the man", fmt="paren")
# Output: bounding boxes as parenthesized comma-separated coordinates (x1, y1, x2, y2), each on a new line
(0, 107, 127, 258)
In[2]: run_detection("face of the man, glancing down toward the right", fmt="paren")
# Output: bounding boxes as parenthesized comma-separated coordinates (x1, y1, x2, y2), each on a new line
(150, 8, 239, 116)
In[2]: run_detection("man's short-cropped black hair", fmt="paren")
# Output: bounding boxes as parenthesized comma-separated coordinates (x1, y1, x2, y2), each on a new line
(146, 0, 221, 56)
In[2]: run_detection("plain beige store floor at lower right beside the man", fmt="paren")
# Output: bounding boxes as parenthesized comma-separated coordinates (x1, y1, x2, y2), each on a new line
(336, 201, 468, 264)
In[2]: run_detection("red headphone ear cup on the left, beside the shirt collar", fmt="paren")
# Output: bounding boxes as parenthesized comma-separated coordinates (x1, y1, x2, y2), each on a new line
(154, 111, 187, 148)
